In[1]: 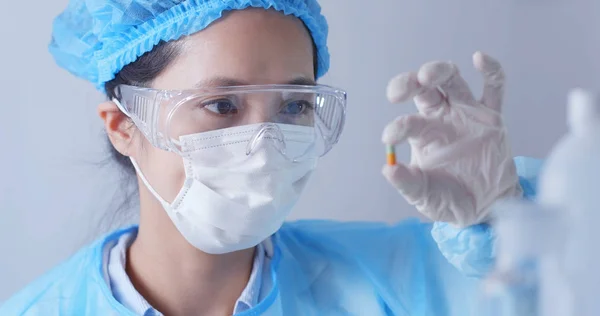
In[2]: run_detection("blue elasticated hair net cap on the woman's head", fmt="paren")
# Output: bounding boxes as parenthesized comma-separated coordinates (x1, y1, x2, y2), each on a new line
(49, 0, 329, 91)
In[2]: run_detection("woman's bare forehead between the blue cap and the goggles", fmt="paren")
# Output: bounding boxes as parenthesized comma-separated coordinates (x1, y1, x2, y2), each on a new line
(153, 9, 315, 89)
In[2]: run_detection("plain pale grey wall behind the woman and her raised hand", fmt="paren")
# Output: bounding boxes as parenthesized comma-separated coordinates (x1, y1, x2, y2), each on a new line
(0, 0, 600, 301)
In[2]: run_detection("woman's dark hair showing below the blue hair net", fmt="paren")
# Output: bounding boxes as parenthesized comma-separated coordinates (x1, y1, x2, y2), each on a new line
(104, 34, 318, 229)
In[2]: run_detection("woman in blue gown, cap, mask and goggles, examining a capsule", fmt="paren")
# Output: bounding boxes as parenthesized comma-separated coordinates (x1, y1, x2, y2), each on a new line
(0, 0, 544, 315)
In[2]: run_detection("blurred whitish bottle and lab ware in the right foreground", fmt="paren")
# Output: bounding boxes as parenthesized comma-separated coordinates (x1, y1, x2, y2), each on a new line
(480, 89, 600, 316)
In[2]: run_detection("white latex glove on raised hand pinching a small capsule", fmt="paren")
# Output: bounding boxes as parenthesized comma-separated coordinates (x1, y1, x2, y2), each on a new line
(383, 52, 522, 227)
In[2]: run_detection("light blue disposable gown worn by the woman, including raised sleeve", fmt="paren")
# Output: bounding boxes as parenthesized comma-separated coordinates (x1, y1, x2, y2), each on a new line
(0, 158, 541, 316)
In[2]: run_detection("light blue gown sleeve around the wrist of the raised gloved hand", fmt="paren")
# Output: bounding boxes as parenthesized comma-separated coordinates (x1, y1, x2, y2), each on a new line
(431, 157, 543, 277)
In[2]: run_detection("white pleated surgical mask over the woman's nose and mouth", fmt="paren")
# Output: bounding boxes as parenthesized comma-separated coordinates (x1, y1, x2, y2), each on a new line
(132, 124, 317, 254)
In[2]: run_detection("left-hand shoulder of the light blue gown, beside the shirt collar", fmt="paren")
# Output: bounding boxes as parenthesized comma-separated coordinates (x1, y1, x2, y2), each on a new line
(0, 230, 135, 315)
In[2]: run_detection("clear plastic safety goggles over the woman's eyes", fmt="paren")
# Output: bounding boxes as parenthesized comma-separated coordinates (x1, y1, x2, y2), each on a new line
(114, 85, 346, 159)
